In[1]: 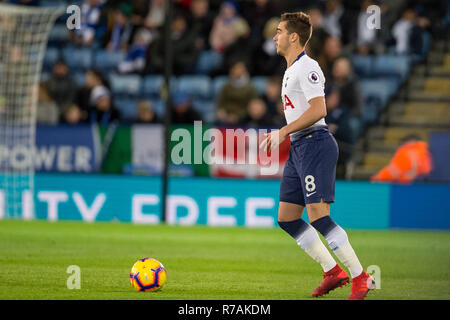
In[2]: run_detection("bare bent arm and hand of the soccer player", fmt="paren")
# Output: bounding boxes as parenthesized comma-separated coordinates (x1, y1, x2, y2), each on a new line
(260, 96, 327, 150)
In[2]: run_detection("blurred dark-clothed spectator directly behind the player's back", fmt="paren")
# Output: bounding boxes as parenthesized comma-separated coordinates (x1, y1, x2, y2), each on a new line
(326, 57, 364, 144)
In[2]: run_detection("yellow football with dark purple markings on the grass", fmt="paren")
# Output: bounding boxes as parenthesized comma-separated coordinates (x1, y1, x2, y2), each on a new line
(130, 258, 167, 292)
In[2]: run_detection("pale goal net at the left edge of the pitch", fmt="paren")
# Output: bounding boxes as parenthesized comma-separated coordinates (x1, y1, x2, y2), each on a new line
(0, 3, 63, 219)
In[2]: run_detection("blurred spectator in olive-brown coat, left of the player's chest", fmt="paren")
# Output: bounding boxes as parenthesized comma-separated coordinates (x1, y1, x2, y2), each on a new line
(217, 61, 258, 125)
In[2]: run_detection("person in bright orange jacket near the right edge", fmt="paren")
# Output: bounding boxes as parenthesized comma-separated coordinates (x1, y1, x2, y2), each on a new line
(370, 135, 432, 183)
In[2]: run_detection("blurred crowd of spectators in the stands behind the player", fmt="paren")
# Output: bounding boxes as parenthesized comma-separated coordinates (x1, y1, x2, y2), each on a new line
(6, 0, 450, 175)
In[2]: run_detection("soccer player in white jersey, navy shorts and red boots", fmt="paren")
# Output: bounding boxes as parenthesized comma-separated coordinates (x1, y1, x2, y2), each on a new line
(261, 12, 375, 300)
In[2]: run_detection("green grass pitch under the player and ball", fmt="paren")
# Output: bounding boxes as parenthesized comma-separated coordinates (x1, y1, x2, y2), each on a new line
(0, 220, 450, 300)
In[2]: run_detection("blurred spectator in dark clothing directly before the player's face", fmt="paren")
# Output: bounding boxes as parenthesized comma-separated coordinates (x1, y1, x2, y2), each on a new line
(252, 17, 286, 76)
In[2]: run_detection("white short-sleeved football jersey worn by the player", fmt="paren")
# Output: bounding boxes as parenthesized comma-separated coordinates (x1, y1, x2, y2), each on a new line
(281, 53, 326, 134)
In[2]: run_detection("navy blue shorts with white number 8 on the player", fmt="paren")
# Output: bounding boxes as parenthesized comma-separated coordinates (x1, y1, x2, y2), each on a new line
(280, 126, 339, 206)
